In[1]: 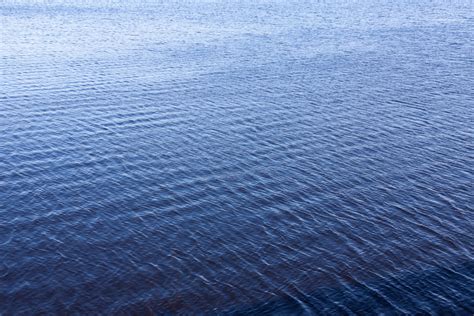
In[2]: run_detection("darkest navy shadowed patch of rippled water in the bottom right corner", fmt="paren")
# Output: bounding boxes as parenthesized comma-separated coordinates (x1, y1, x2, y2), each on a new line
(230, 263, 474, 315)
